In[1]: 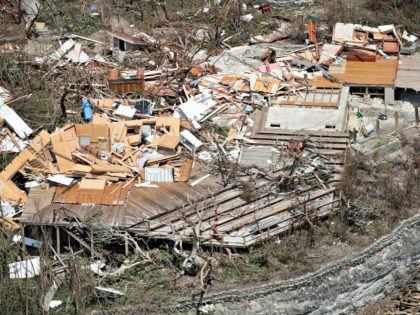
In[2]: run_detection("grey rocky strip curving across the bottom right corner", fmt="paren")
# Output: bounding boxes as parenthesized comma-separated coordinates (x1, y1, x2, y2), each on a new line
(171, 215, 420, 315)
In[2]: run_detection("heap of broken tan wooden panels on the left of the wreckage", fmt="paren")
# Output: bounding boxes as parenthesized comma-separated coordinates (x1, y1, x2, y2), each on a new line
(0, 93, 197, 225)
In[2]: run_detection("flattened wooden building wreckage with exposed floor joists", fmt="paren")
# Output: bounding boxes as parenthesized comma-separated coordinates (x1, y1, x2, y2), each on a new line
(0, 14, 418, 254)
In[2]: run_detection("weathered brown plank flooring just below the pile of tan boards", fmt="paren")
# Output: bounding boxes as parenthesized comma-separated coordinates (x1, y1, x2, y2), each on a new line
(21, 183, 217, 228)
